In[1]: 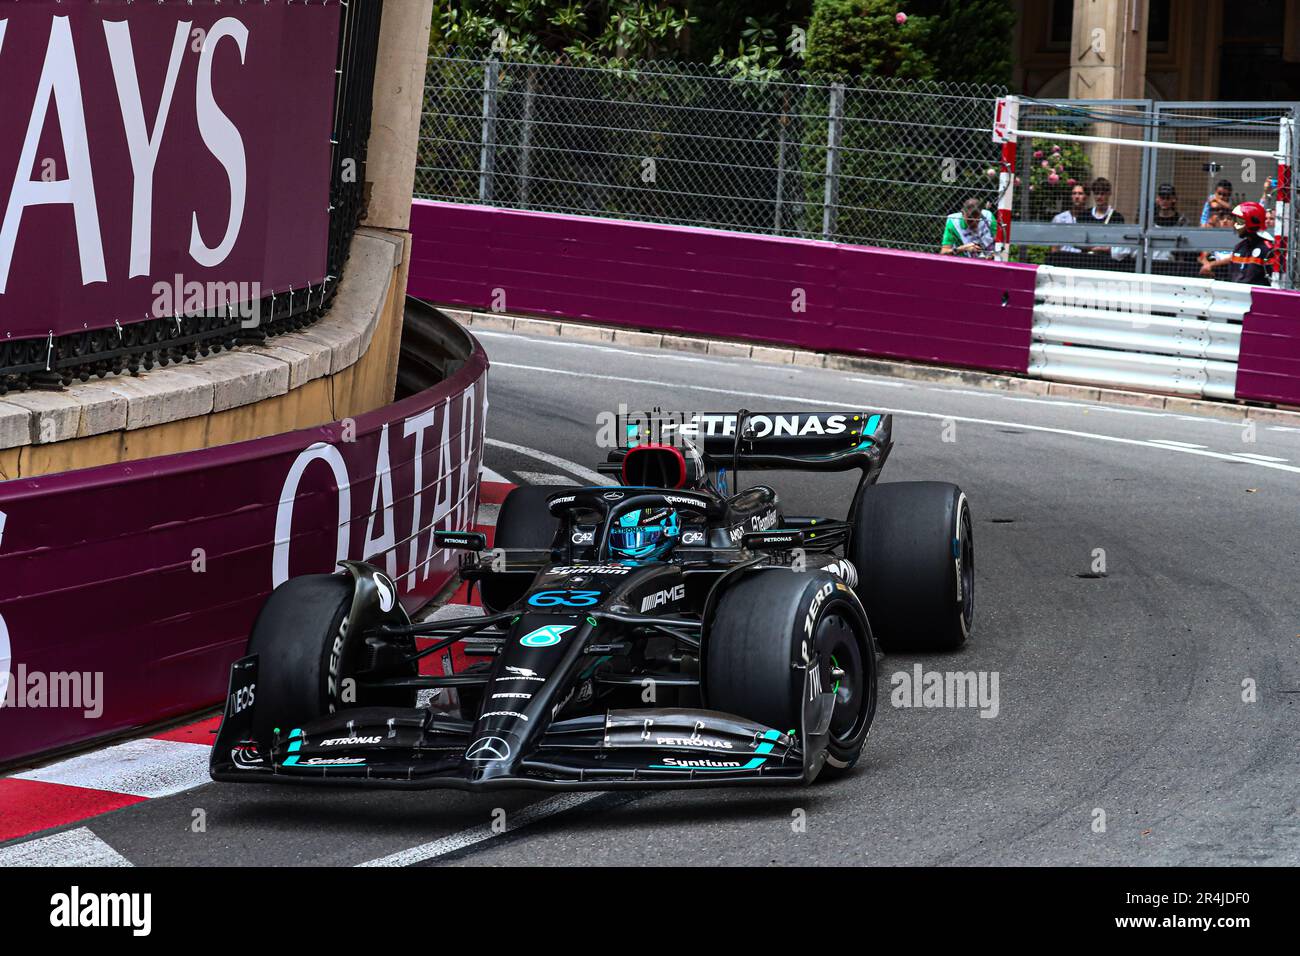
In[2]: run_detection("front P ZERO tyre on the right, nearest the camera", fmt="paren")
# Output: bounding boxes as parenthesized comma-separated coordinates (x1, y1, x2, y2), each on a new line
(705, 568, 876, 774)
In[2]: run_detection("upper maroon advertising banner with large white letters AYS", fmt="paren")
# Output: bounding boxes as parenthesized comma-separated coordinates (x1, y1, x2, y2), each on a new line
(0, 0, 342, 338)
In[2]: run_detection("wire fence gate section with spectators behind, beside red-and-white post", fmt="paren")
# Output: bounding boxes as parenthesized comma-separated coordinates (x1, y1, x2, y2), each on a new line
(1011, 100, 1296, 285)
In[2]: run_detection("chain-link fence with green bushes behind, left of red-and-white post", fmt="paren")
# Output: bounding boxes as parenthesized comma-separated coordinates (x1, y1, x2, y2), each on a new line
(416, 51, 1005, 251)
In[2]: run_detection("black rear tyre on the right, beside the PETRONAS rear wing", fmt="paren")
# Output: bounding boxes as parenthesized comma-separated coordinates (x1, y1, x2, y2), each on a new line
(848, 481, 975, 652)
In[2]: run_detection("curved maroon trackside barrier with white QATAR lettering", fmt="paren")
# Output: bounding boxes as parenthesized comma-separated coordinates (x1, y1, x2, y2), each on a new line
(0, 317, 488, 763)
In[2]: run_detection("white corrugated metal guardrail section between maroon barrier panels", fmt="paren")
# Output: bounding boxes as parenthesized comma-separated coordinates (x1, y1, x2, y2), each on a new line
(1030, 265, 1251, 398)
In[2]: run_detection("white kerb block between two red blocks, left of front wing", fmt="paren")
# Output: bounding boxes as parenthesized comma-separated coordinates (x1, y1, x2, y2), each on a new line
(14, 737, 212, 797)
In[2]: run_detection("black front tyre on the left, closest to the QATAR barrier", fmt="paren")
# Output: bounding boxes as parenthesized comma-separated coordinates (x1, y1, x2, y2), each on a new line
(248, 574, 416, 741)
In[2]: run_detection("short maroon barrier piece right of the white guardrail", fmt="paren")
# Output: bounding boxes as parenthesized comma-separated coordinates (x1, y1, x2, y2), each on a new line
(1236, 287, 1300, 405)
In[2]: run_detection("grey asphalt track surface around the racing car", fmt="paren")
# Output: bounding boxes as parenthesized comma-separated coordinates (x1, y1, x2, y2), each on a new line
(2, 333, 1300, 865)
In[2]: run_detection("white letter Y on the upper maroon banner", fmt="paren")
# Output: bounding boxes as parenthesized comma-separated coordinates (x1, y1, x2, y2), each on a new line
(104, 20, 190, 278)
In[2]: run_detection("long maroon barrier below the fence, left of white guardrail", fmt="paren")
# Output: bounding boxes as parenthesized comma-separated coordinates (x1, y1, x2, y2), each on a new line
(408, 200, 1035, 372)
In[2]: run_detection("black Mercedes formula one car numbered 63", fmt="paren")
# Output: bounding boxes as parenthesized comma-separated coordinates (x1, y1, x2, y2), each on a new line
(211, 411, 975, 790)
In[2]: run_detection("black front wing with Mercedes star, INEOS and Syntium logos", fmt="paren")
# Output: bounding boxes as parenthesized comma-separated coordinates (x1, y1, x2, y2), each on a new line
(211, 654, 835, 790)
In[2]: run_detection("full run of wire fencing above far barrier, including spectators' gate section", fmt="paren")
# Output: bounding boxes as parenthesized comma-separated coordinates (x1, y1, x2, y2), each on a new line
(416, 56, 1295, 283)
